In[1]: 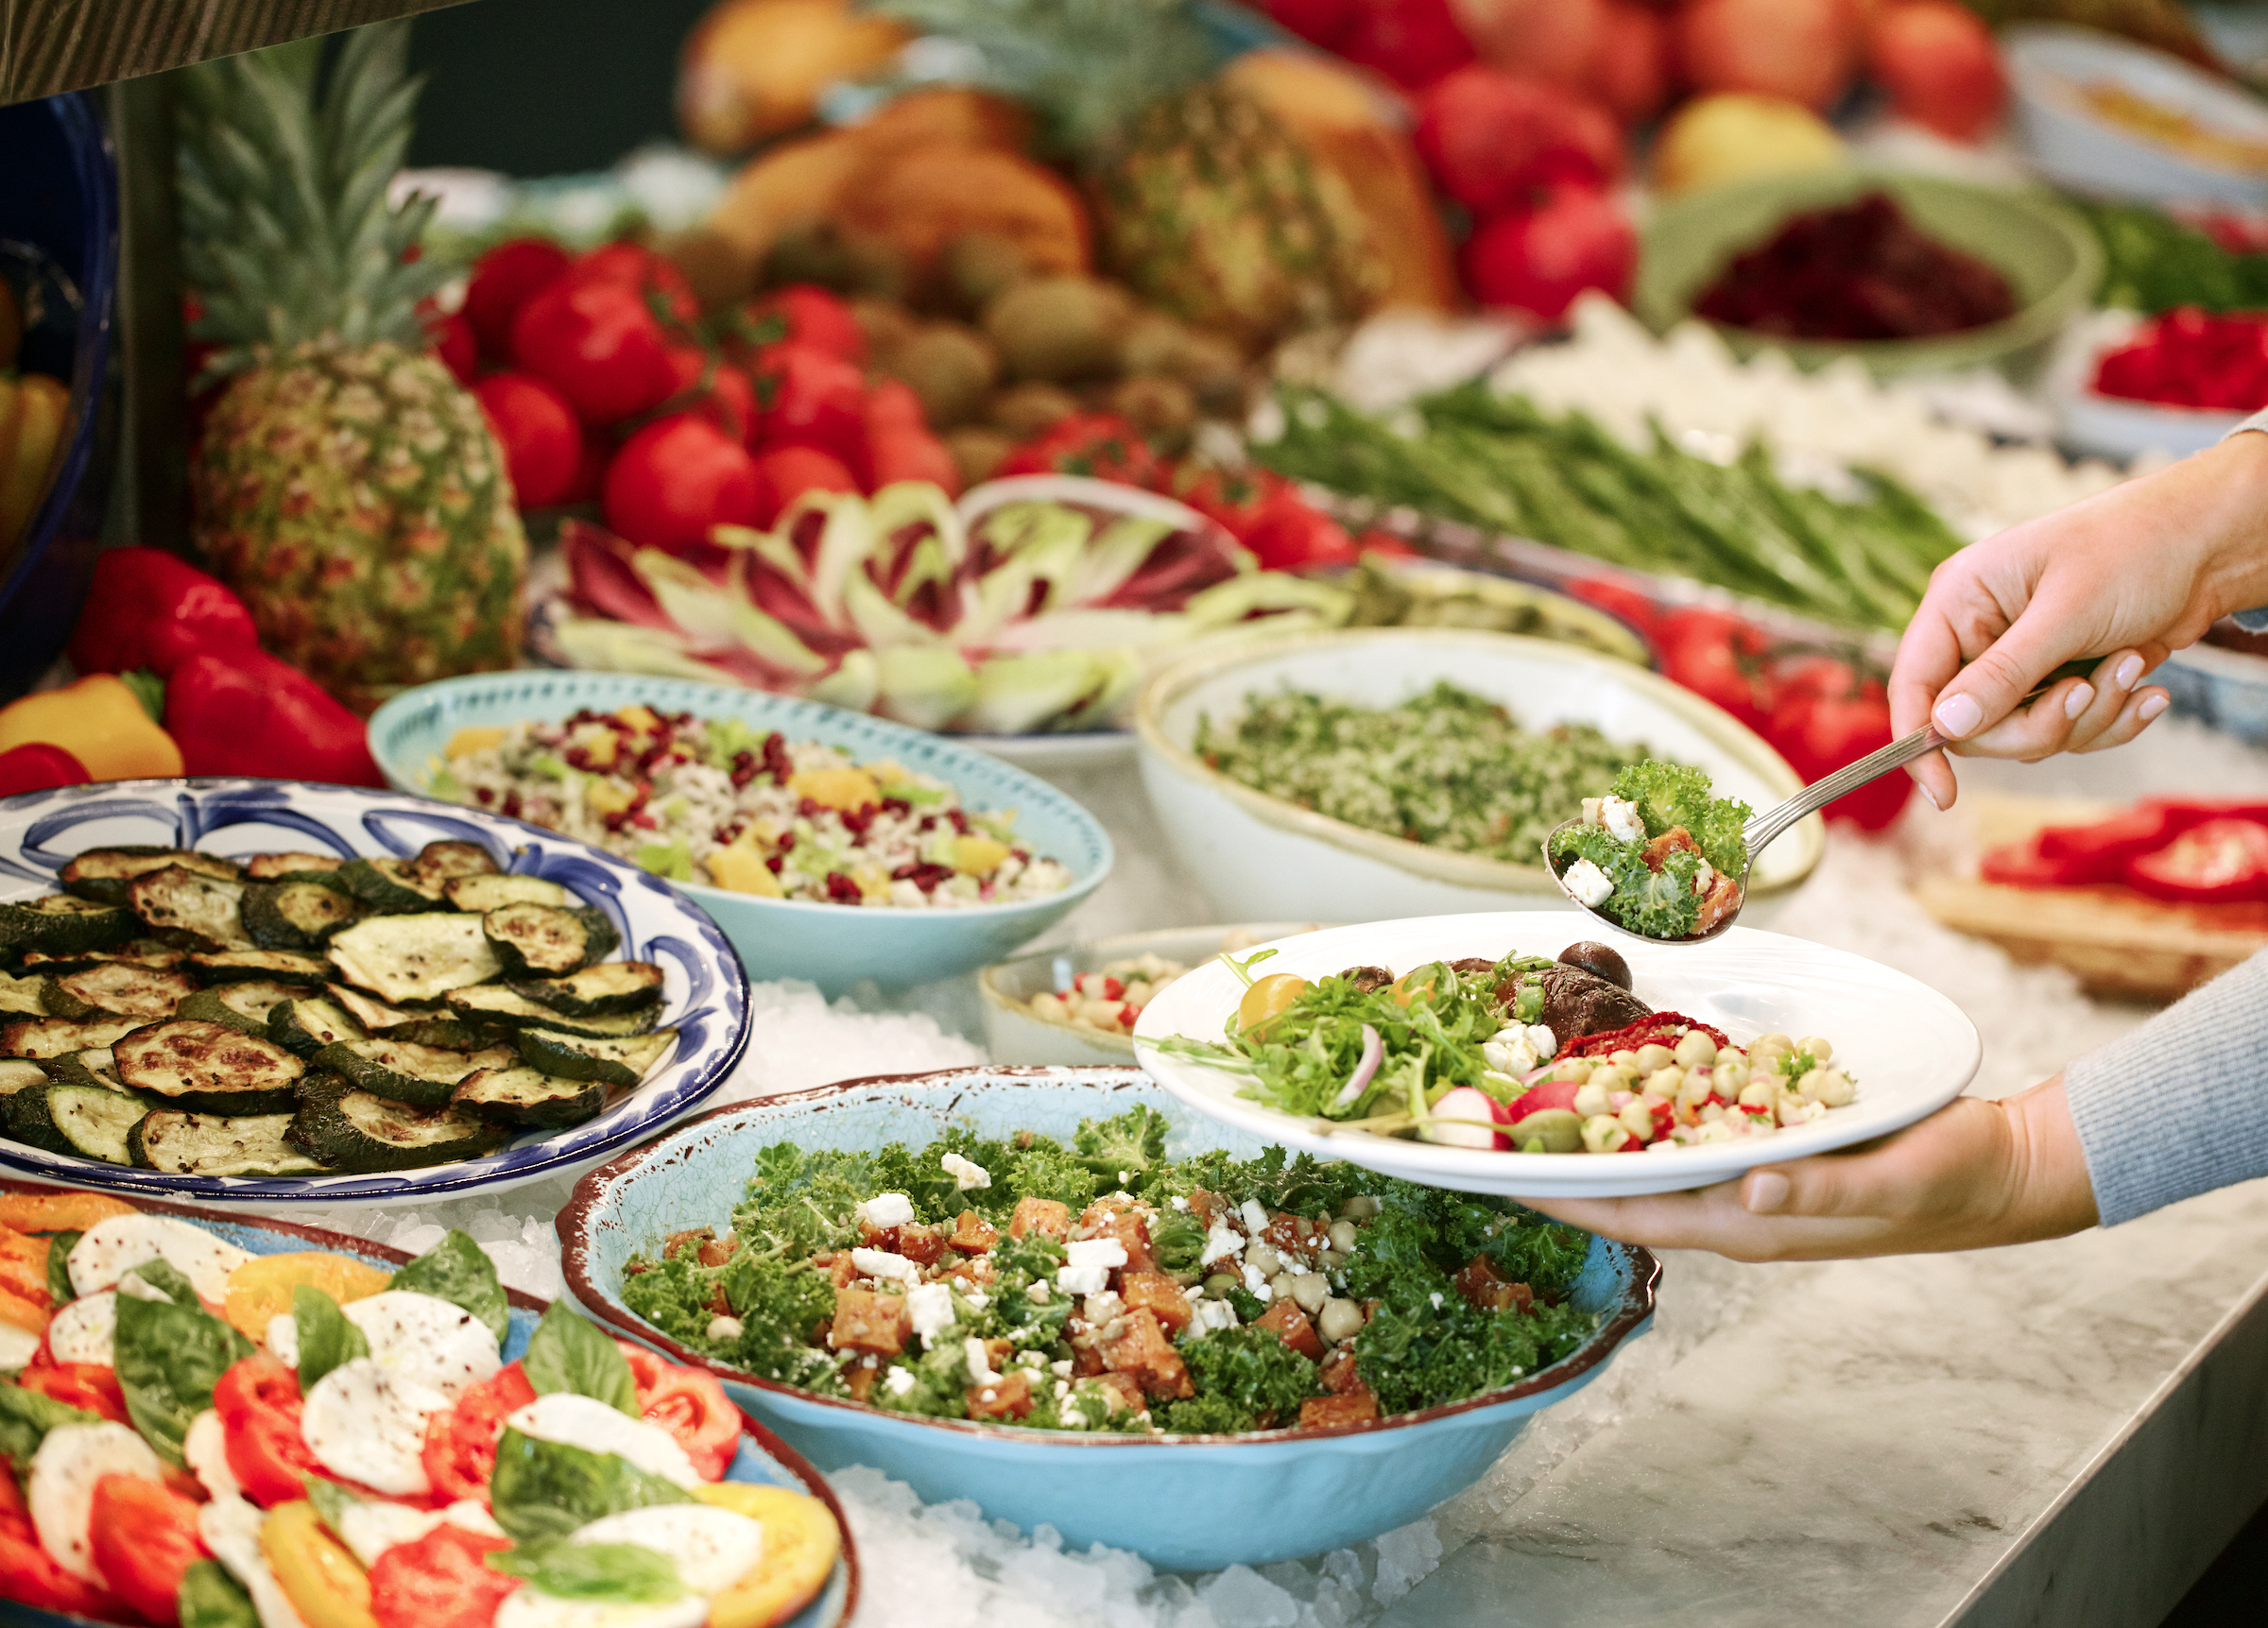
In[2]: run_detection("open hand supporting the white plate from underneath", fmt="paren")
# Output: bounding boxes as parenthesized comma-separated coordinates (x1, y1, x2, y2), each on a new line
(1521, 1074, 2096, 1260)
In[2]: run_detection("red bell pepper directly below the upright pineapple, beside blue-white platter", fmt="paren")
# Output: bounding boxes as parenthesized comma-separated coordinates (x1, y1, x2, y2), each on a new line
(165, 651, 386, 787)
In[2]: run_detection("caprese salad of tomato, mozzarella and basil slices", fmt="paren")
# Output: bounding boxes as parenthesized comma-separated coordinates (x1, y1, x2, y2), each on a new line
(0, 1192, 841, 1628)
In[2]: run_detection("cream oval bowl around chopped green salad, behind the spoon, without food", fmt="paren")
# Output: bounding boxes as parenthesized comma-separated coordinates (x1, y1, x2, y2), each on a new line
(1134, 628, 1826, 920)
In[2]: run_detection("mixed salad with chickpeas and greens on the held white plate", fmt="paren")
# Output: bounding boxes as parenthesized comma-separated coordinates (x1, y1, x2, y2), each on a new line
(1157, 943, 1858, 1154)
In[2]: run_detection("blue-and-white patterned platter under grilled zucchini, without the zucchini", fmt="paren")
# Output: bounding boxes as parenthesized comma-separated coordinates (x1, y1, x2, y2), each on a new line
(0, 780, 748, 1207)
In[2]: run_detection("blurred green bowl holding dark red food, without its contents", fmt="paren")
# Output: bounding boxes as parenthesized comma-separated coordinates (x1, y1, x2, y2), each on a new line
(1631, 168, 2103, 379)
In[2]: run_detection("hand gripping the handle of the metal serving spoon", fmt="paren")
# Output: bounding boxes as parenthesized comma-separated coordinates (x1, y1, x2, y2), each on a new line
(1889, 433, 2268, 807)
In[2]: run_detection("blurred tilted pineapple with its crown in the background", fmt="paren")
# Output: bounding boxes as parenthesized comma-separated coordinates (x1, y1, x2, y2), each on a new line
(873, 0, 1385, 350)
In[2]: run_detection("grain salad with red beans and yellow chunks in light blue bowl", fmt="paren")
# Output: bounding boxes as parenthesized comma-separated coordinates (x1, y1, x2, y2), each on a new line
(429, 705, 1071, 909)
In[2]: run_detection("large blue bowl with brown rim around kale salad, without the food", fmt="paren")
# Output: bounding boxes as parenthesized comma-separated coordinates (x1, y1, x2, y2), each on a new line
(558, 1068, 1660, 1571)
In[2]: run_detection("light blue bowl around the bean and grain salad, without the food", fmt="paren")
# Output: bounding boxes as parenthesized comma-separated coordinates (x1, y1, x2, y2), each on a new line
(369, 669, 1111, 998)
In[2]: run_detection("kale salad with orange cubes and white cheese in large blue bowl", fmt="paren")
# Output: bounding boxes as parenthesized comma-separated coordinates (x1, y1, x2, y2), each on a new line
(624, 1106, 1599, 1435)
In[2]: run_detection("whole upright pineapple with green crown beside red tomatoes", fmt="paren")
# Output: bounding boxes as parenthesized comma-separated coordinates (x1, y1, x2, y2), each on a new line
(180, 23, 528, 712)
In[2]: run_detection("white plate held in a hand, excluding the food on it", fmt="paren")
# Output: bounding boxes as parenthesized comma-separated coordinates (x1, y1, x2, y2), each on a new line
(1134, 912, 1983, 1197)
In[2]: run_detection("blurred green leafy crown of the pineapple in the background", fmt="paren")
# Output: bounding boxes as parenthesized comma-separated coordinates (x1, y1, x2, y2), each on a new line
(862, 0, 1220, 157)
